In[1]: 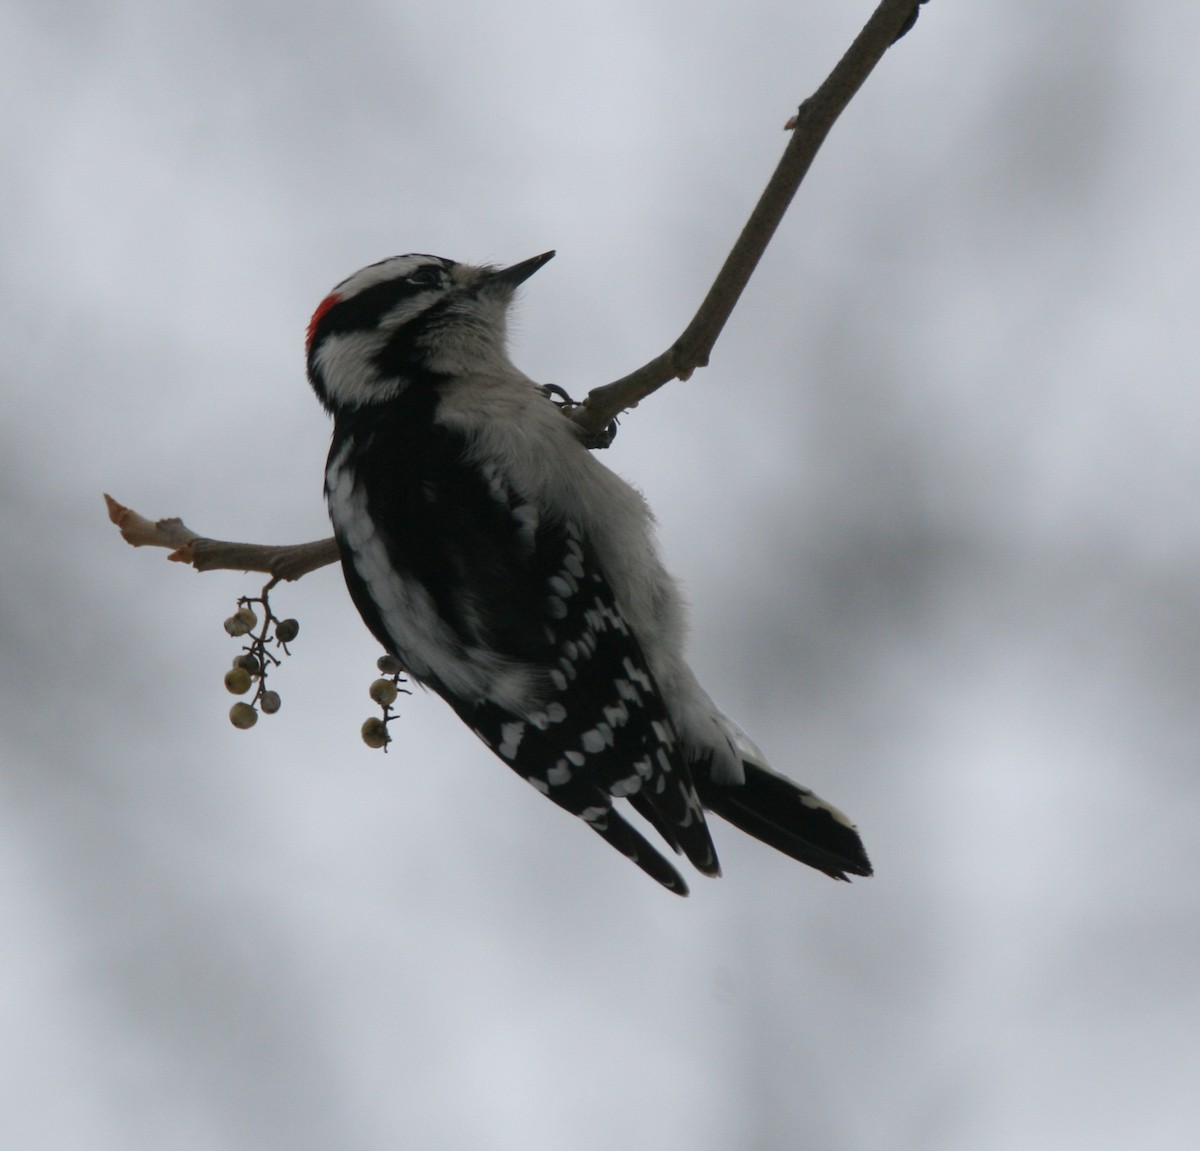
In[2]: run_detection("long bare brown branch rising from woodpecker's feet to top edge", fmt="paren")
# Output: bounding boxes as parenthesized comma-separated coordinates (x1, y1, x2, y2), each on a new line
(570, 0, 918, 434)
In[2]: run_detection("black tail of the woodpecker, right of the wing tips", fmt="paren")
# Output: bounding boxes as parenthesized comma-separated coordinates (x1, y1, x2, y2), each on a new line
(696, 761, 871, 880)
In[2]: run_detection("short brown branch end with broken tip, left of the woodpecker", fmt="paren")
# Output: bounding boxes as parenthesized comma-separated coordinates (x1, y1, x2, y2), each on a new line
(104, 494, 338, 580)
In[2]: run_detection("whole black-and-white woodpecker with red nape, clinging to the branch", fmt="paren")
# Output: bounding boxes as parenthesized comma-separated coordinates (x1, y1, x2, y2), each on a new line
(308, 252, 871, 894)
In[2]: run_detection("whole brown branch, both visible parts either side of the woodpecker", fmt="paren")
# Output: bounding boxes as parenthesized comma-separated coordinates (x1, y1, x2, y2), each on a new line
(104, 0, 924, 580)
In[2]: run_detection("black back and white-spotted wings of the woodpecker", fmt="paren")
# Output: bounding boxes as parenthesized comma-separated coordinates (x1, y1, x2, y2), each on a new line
(331, 413, 719, 894)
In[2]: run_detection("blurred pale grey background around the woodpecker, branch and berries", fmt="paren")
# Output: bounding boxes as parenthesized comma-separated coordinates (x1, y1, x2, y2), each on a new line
(0, 0, 1200, 1151)
